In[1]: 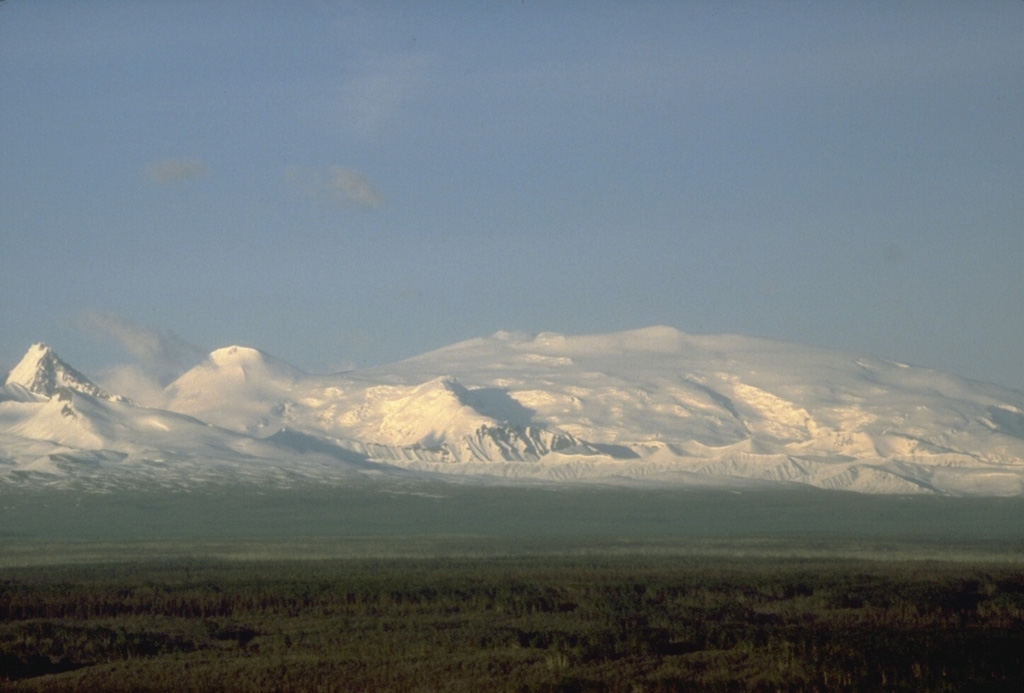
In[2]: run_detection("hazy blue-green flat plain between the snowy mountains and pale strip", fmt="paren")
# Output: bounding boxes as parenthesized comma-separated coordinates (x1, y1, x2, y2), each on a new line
(6, 480, 1024, 546)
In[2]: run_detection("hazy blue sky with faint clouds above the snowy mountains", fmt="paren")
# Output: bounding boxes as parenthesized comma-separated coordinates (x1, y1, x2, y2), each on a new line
(0, 0, 1024, 394)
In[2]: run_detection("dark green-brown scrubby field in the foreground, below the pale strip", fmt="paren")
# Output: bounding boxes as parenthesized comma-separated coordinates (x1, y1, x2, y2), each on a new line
(0, 545, 1024, 691)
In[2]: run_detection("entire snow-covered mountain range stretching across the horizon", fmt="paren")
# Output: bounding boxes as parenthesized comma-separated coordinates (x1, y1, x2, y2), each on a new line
(0, 328, 1024, 495)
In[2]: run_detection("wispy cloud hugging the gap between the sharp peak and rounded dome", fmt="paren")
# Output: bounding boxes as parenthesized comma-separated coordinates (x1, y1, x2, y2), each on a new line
(79, 310, 206, 405)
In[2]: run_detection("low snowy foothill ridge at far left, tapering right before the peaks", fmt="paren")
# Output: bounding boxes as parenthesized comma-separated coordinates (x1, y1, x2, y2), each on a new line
(0, 388, 385, 490)
